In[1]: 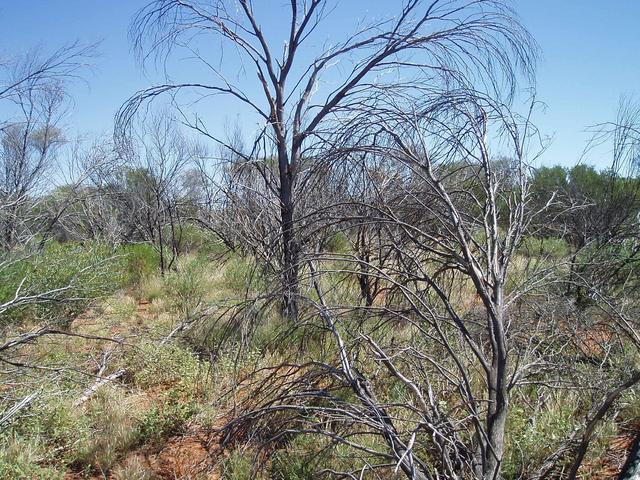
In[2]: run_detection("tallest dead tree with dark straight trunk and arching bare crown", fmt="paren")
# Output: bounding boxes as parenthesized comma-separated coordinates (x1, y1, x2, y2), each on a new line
(117, 0, 536, 320)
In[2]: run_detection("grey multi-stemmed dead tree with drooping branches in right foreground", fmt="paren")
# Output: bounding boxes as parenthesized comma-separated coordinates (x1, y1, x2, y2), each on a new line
(222, 90, 547, 479)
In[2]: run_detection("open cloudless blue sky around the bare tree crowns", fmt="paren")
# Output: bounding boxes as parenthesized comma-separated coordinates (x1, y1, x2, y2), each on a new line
(0, 0, 640, 166)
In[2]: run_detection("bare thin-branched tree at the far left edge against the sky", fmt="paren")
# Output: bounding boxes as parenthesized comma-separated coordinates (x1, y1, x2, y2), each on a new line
(0, 44, 95, 252)
